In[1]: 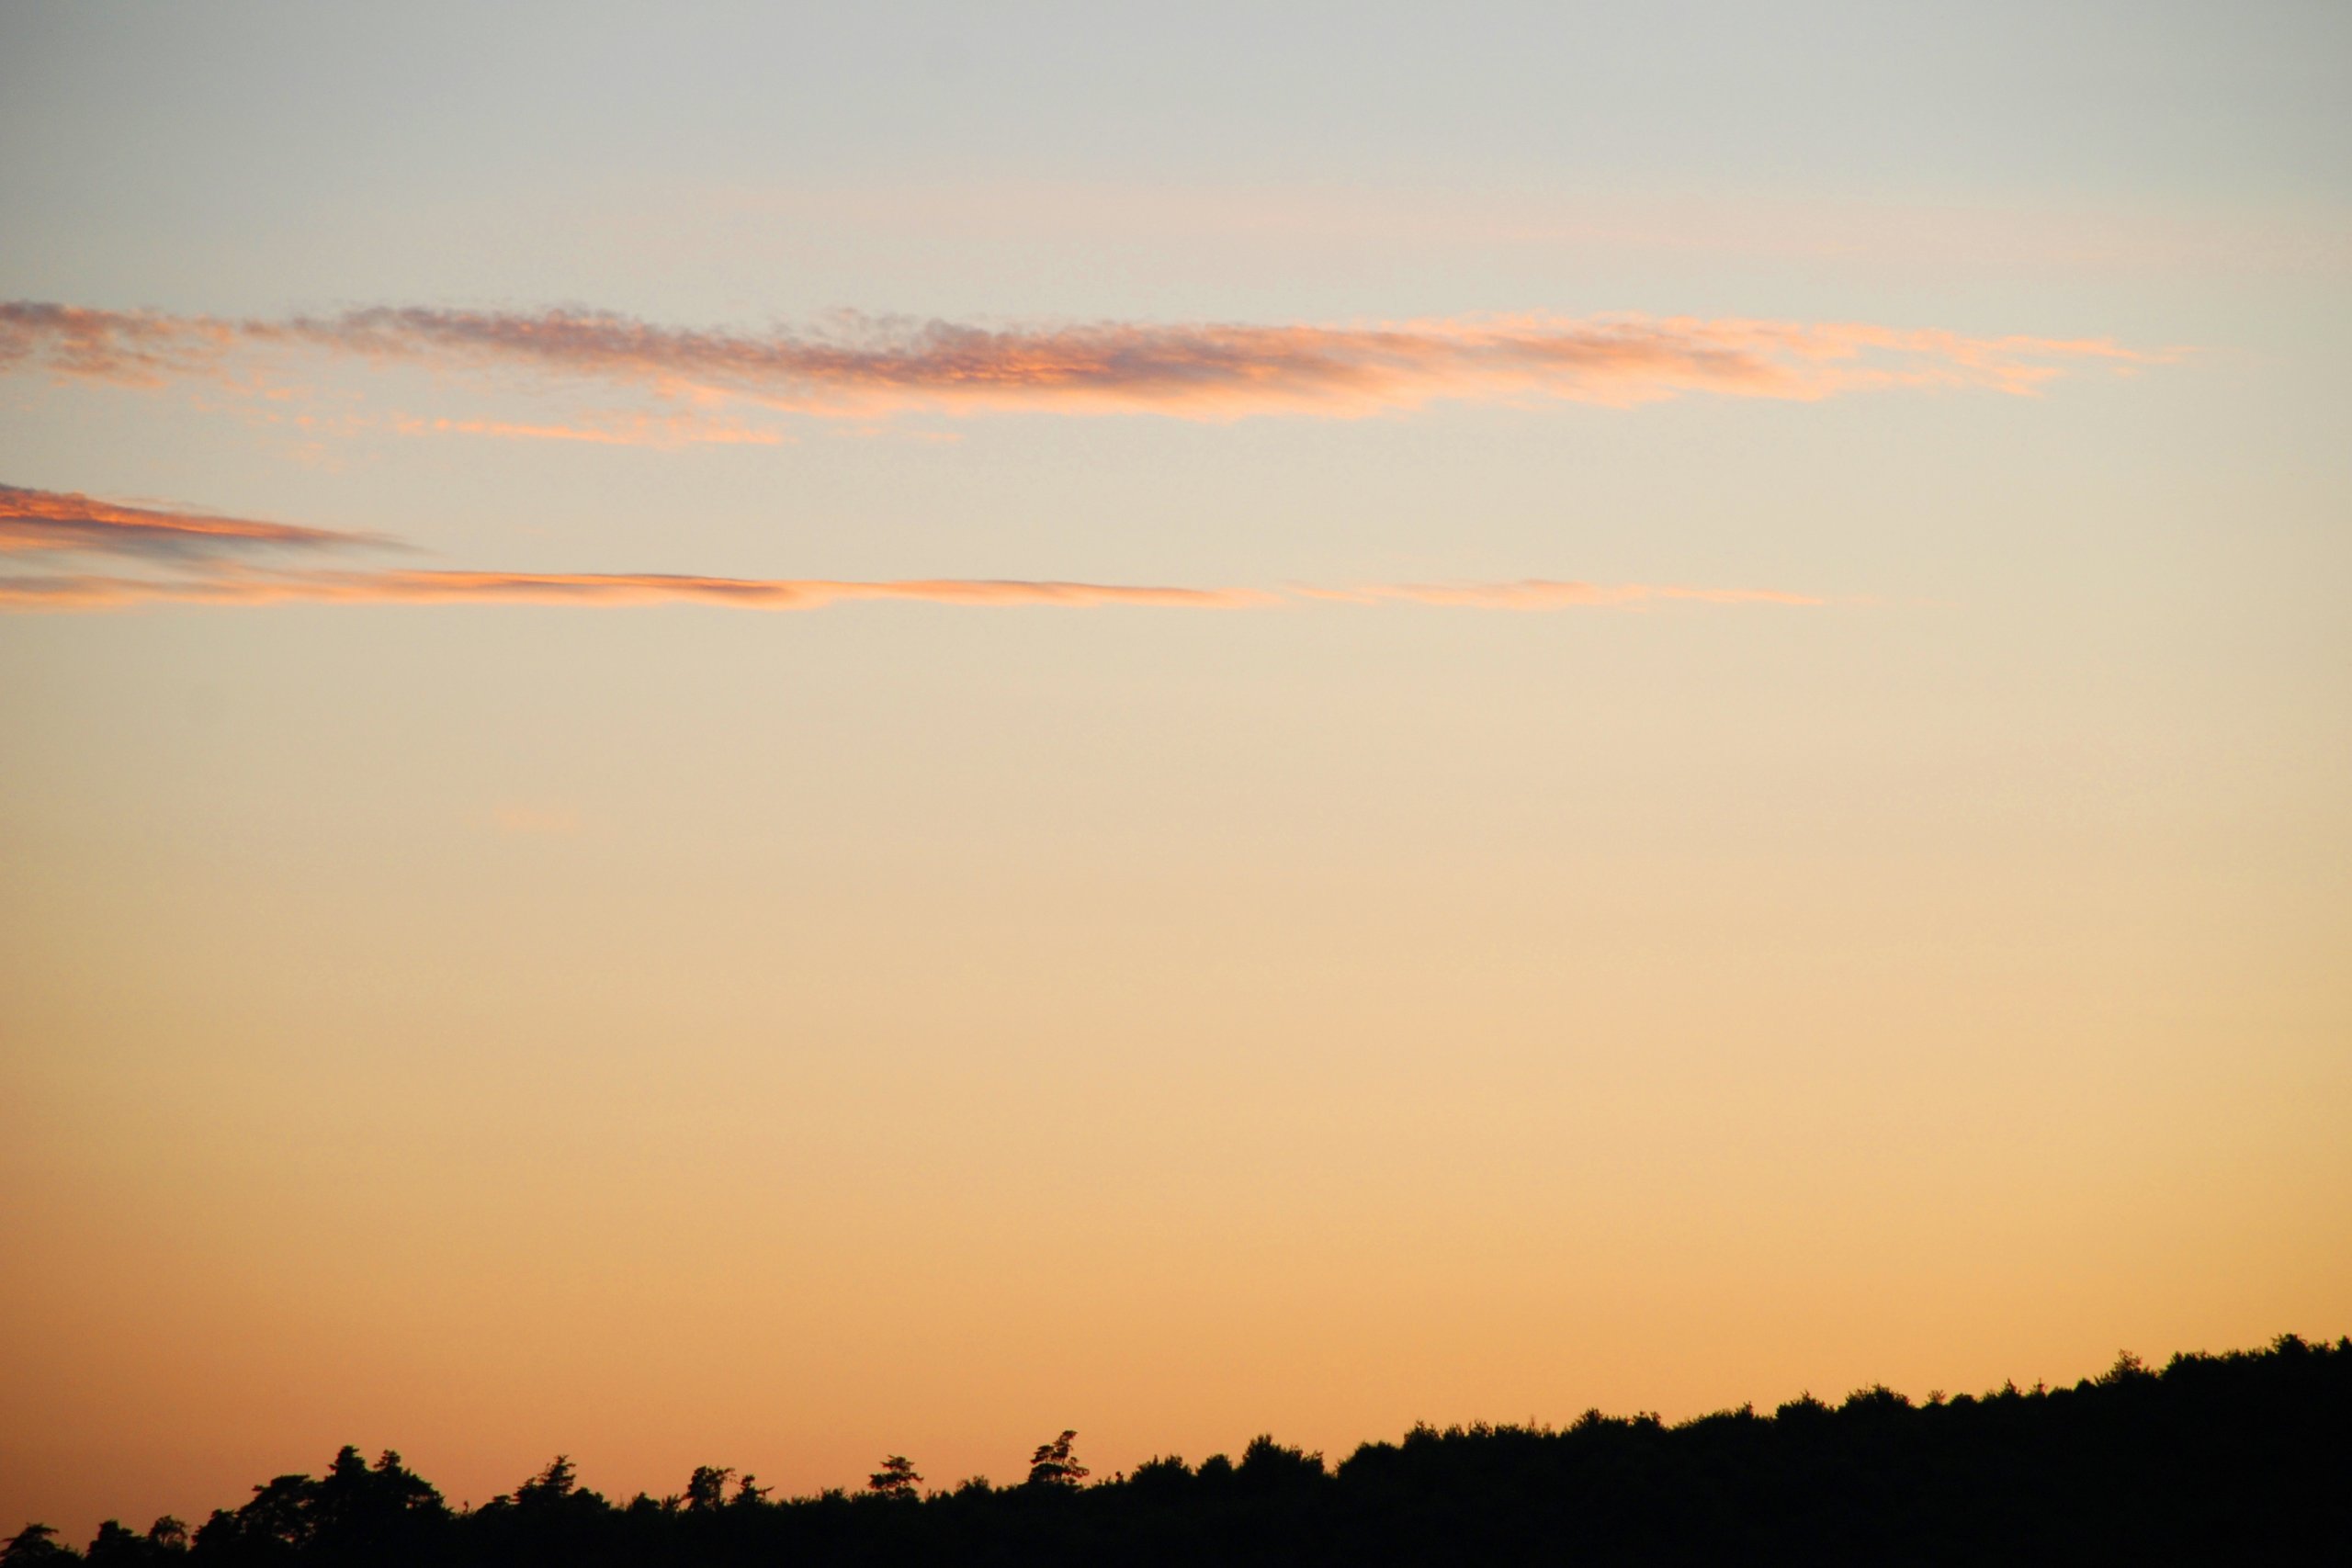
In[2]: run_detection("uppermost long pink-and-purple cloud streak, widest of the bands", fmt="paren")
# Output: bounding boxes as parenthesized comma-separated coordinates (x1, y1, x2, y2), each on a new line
(0, 303, 2168, 419)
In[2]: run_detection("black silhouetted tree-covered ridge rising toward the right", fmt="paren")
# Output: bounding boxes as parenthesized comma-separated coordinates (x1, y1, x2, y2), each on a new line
(0, 1336, 2352, 1568)
